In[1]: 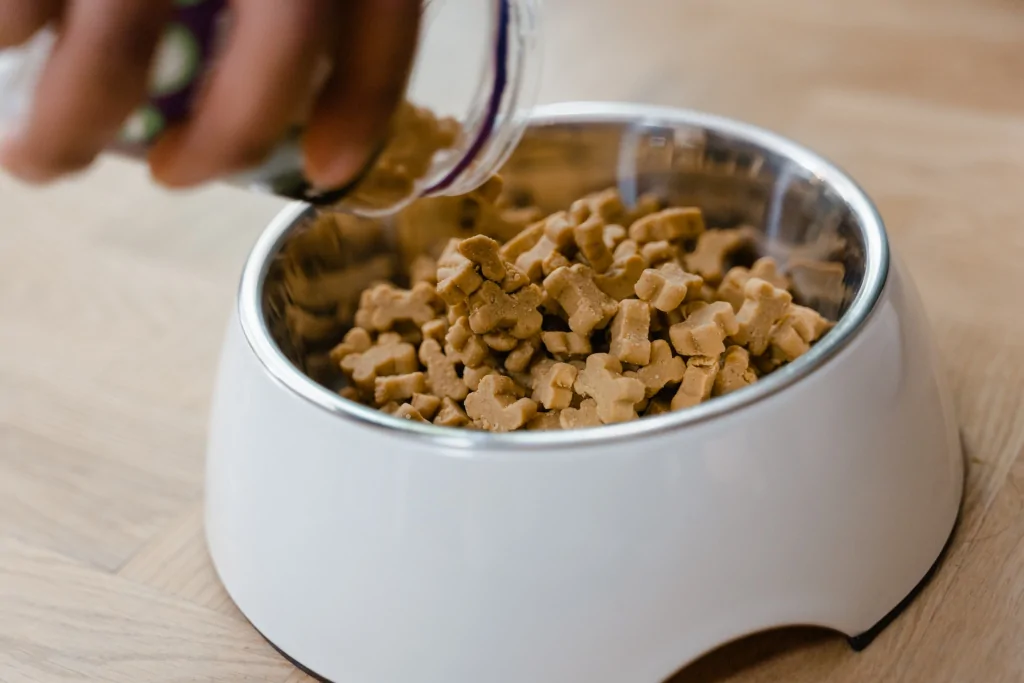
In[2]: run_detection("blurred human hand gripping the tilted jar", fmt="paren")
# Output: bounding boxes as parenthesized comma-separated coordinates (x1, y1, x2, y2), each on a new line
(0, 0, 420, 187)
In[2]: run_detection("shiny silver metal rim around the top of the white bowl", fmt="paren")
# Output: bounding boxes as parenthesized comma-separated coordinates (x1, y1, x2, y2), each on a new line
(238, 102, 890, 458)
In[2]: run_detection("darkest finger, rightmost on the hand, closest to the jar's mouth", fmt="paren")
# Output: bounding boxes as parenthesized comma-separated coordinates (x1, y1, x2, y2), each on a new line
(303, 0, 421, 188)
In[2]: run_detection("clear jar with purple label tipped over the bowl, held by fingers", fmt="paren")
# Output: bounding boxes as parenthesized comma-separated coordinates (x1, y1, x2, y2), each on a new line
(0, 0, 540, 216)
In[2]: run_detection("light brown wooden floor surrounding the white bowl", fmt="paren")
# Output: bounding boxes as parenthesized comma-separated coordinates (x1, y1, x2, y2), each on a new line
(0, 0, 1024, 683)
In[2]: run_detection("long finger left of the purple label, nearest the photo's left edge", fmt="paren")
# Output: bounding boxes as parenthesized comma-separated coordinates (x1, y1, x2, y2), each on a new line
(0, 0, 171, 182)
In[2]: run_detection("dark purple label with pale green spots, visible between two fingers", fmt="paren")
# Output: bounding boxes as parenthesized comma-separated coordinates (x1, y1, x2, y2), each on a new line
(121, 0, 227, 146)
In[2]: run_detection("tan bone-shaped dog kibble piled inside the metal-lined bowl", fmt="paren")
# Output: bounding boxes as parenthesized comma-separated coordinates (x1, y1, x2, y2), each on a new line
(276, 185, 844, 432)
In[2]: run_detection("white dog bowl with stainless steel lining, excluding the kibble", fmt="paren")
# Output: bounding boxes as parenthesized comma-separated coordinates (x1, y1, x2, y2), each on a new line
(206, 104, 964, 683)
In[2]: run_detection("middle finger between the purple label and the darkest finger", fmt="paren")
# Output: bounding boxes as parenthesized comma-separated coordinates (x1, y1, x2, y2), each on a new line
(150, 0, 331, 186)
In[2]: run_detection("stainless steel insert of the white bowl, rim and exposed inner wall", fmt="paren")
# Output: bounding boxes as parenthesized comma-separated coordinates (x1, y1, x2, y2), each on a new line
(239, 102, 889, 456)
